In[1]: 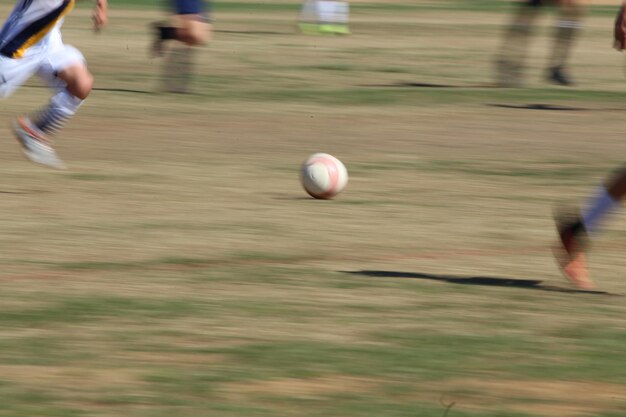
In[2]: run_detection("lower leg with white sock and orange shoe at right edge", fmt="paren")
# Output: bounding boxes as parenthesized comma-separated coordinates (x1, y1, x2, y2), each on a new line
(556, 167, 626, 289)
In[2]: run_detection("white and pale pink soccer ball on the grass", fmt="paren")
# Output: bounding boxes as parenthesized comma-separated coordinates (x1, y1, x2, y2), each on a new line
(300, 153, 348, 200)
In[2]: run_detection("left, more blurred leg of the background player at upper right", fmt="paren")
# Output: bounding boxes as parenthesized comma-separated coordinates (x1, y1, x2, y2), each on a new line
(496, 0, 545, 87)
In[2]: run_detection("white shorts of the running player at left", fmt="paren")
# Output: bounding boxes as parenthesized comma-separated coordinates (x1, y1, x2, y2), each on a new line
(0, 33, 85, 97)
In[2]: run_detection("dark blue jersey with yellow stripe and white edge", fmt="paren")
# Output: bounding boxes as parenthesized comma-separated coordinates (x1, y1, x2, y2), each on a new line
(0, 0, 75, 58)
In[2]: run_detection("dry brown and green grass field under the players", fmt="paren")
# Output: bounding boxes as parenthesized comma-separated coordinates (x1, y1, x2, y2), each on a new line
(0, 0, 626, 417)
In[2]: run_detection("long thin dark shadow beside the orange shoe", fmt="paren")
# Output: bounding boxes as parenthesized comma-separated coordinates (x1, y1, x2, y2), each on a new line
(340, 270, 622, 296)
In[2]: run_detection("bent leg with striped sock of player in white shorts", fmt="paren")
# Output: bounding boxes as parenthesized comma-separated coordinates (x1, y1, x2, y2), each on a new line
(14, 45, 93, 169)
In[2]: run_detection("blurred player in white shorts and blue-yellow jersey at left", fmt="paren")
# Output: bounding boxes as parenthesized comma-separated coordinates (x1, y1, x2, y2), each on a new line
(0, 0, 108, 169)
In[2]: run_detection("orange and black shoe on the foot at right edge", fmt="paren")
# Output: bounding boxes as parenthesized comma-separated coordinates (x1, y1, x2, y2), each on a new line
(554, 208, 595, 290)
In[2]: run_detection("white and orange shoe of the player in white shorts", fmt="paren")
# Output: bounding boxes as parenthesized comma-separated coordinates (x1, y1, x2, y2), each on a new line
(13, 117, 65, 169)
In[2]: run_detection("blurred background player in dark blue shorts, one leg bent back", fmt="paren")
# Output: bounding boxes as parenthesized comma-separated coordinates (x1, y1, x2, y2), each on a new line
(152, 0, 211, 93)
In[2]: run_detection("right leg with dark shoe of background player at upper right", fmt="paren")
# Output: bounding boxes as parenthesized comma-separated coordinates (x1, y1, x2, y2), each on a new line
(548, 0, 583, 86)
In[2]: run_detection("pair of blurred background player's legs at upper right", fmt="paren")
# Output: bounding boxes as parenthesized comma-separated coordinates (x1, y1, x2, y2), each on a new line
(497, 0, 584, 87)
